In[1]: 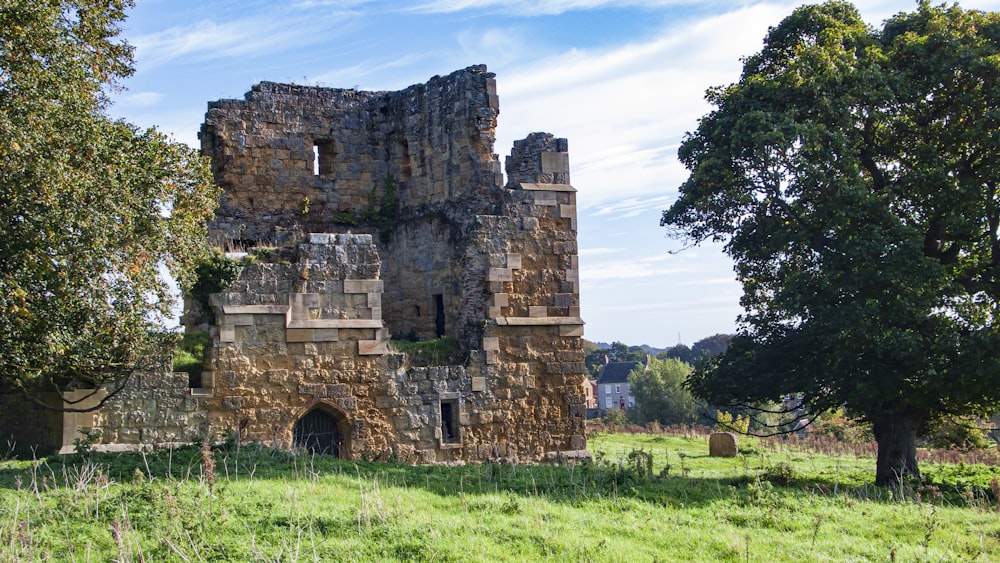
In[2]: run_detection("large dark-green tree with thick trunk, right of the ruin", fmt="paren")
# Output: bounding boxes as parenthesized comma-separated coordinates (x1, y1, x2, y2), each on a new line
(661, 1, 1000, 484)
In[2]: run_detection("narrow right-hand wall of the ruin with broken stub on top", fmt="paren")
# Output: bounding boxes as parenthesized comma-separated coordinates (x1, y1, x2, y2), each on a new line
(492, 133, 586, 450)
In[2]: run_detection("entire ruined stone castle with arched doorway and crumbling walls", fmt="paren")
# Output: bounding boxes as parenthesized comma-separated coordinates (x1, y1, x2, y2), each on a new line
(0, 66, 586, 463)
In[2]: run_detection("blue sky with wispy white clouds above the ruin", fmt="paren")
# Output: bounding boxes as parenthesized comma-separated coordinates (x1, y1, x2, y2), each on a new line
(110, 0, 1000, 347)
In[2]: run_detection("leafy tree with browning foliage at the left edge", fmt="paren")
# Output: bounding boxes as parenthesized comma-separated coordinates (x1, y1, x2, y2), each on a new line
(0, 0, 218, 410)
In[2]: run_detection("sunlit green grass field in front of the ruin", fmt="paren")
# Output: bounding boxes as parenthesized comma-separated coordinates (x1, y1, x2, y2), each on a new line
(0, 431, 1000, 562)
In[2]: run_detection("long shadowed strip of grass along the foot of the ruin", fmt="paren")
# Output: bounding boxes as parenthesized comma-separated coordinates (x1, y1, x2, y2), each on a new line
(0, 445, 1000, 507)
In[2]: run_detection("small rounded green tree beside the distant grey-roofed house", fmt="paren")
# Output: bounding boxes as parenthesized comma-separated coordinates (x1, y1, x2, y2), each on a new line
(628, 358, 698, 424)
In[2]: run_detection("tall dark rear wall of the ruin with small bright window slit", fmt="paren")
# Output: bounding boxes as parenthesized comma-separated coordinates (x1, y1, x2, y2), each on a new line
(201, 66, 504, 356)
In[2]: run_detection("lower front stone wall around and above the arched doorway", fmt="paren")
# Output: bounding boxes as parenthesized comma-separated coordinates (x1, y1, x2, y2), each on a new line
(203, 234, 393, 456)
